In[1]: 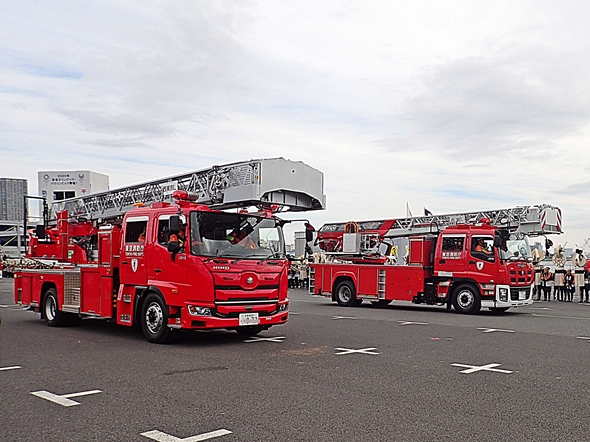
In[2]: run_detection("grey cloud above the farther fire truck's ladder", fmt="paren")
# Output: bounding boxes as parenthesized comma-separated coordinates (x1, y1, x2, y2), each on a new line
(384, 48, 590, 159)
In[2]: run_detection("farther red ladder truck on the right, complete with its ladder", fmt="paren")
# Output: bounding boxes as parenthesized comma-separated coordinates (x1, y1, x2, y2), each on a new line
(310, 205, 561, 313)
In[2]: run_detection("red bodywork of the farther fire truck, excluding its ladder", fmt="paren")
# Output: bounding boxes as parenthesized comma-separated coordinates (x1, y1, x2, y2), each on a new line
(310, 224, 534, 308)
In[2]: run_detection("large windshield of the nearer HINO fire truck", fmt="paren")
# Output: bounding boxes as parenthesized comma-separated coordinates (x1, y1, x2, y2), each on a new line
(190, 212, 285, 259)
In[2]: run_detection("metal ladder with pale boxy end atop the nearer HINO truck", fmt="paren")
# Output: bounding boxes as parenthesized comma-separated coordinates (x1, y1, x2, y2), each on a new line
(50, 158, 326, 220)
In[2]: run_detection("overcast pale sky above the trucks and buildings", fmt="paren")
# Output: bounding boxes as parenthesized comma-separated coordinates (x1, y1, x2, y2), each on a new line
(0, 0, 590, 247)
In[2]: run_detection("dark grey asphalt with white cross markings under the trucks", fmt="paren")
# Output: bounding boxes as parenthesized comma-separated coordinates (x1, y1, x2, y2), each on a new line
(0, 279, 590, 442)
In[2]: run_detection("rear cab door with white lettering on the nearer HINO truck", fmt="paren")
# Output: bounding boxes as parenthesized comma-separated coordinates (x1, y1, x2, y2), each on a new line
(120, 215, 149, 285)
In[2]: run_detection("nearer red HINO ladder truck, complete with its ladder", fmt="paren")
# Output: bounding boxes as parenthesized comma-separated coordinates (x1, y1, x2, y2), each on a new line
(14, 158, 325, 343)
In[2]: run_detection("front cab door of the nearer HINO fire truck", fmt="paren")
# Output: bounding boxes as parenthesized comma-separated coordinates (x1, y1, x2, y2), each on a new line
(148, 215, 190, 285)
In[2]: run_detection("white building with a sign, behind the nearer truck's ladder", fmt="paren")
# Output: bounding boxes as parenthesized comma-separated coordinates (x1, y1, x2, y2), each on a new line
(37, 170, 109, 206)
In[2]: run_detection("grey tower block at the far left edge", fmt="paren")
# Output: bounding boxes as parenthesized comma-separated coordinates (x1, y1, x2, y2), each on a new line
(0, 178, 28, 258)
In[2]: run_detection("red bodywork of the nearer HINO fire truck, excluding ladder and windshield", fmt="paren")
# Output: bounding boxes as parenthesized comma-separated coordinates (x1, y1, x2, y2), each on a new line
(14, 202, 289, 338)
